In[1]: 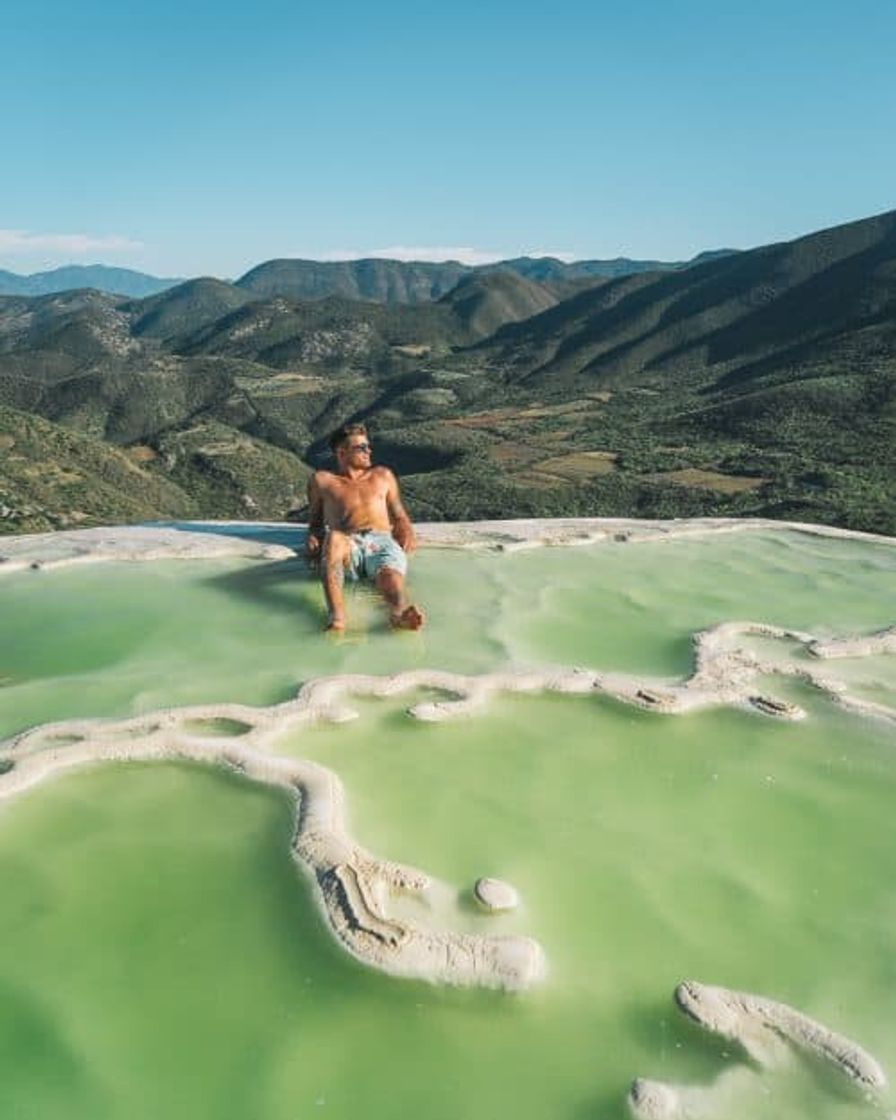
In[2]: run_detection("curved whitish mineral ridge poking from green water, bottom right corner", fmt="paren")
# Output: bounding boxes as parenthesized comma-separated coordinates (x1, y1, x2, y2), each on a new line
(628, 980, 887, 1120)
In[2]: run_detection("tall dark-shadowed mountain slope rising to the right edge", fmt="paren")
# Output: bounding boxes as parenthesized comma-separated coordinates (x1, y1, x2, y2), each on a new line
(488, 212, 896, 391)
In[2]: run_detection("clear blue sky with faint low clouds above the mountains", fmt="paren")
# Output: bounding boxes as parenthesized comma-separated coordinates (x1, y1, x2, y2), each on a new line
(0, 0, 896, 277)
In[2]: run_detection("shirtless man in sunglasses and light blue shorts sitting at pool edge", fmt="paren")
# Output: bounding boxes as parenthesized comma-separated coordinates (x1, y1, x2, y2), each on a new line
(306, 423, 423, 632)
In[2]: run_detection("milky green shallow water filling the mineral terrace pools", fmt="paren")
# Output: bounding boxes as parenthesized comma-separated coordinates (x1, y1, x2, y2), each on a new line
(0, 532, 896, 1120)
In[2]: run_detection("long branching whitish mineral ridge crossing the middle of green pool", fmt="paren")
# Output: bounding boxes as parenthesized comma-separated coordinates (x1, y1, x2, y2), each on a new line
(0, 623, 896, 989)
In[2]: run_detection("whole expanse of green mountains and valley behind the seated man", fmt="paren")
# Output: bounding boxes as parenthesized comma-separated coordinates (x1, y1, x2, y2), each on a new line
(0, 212, 896, 533)
